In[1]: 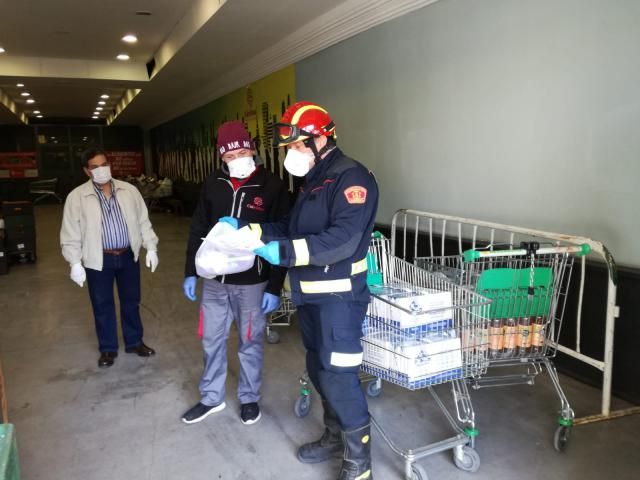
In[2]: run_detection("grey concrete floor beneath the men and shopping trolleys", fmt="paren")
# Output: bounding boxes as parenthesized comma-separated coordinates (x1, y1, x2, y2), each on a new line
(0, 205, 640, 480)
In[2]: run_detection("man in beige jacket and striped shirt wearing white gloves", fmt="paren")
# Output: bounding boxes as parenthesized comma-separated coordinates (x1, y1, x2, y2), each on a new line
(60, 148, 158, 367)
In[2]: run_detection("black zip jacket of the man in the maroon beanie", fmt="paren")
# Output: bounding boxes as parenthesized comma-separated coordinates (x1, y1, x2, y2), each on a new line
(184, 165, 290, 296)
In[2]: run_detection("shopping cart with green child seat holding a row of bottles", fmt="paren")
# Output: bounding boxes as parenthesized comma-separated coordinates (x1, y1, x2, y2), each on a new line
(414, 242, 589, 451)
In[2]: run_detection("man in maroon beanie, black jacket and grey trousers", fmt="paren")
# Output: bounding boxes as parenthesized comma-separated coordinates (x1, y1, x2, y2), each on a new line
(182, 120, 289, 425)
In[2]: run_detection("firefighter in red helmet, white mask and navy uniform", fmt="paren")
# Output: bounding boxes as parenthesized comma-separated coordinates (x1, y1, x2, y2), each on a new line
(220, 102, 378, 480)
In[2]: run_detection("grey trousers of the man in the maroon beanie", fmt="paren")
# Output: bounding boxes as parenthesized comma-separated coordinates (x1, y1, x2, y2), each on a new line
(200, 280, 267, 406)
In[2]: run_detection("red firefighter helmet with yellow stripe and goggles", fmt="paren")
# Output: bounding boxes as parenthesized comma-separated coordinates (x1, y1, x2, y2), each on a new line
(273, 102, 336, 147)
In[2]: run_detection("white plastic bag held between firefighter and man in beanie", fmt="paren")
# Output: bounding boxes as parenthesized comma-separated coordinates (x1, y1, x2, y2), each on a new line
(196, 223, 264, 279)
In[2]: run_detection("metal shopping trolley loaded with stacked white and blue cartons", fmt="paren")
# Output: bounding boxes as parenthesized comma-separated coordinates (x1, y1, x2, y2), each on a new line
(362, 249, 490, 480)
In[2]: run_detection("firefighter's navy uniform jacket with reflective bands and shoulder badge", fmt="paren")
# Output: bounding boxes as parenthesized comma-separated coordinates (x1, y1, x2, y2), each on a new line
(251, 148, 378, 305)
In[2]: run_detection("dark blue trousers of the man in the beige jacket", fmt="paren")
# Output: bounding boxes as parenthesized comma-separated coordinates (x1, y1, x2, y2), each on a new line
(86, 250, 143, 352)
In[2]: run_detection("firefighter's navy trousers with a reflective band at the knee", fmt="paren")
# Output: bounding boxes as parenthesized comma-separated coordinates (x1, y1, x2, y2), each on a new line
(297, 302, 369, 430)
